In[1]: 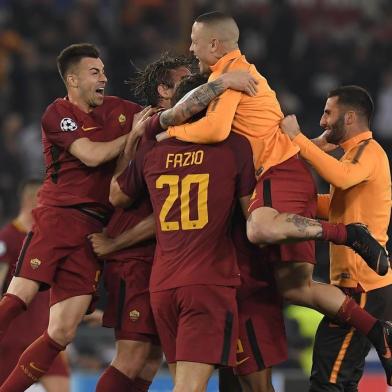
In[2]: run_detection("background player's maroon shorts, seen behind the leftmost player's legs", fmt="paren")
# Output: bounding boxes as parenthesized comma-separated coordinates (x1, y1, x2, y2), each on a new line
(0, 291, 69, 385)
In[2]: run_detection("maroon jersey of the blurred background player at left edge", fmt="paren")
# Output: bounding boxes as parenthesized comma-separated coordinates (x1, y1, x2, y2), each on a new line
(0, 221, 27, 292)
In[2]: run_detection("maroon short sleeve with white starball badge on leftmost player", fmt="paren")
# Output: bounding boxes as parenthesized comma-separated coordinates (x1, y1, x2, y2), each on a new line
(42, 105, 86, 150)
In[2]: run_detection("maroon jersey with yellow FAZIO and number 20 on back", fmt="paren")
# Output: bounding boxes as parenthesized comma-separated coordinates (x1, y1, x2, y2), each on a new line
(119, 133, 255, 291)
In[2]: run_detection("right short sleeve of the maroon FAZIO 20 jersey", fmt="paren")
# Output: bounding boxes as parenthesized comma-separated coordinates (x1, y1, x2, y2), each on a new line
(226, 132, 256, 197)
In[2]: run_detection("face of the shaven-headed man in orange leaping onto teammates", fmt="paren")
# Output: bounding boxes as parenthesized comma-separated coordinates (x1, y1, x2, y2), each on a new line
(189, 22, 217, 73)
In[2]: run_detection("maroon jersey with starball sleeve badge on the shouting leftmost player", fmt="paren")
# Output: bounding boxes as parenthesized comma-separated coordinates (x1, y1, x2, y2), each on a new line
(39, 96, 141, 209)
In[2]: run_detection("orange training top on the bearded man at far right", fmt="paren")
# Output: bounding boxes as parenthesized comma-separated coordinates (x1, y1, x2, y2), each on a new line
(293, 131, 392, 291)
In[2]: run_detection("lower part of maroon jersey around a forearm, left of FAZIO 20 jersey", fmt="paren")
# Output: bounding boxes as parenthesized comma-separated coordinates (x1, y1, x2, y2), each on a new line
(106, 199, 155, 263)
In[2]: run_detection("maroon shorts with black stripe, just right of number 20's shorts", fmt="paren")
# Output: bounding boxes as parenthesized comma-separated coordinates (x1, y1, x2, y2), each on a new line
(235, 287, 287, 376)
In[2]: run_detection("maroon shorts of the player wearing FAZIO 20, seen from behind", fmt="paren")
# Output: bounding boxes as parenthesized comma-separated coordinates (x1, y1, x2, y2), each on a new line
(151, 285, 238, 366)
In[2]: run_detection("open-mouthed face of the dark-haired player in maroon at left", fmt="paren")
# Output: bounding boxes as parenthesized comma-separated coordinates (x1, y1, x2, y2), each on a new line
(67, 57, 108, 111)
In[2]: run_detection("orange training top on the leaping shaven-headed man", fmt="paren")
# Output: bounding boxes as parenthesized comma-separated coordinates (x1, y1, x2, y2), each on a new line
(167, 50, 298, 175)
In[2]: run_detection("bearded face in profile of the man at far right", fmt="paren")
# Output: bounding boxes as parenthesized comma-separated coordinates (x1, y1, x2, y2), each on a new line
(320, 97, 347, 144)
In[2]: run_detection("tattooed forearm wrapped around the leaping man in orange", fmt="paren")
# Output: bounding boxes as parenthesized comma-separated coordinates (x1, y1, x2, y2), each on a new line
(160, 79, 226, 129)
